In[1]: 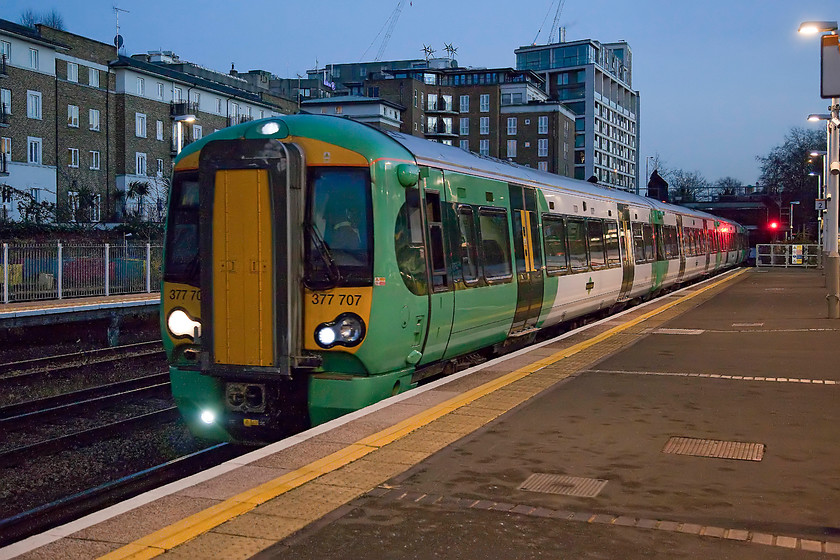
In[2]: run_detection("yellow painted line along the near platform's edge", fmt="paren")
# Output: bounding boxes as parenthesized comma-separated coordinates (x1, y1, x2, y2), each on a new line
(99, 269, 748, 560)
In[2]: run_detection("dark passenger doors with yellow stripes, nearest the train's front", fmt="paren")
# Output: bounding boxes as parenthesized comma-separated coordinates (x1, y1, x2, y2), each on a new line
(508, 185, 543, 334)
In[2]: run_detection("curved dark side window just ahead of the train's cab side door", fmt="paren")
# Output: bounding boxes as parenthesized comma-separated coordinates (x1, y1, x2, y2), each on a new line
(394, 189, 427, 296)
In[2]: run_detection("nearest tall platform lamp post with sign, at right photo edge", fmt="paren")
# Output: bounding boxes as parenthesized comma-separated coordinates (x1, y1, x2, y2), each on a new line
(799, 21, 840, 319)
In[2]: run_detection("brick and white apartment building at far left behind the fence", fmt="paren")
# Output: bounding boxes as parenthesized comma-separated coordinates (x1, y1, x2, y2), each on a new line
(0, 20, 297, 222)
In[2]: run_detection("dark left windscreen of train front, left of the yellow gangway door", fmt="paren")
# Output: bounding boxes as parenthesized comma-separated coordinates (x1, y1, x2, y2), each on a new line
(164, 173, 201, 286)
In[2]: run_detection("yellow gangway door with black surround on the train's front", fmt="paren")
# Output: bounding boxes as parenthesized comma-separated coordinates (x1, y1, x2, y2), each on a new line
(199, 140, 303, 376)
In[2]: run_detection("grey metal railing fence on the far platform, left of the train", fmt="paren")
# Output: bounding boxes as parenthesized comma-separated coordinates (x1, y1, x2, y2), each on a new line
(0, 243, 163, 303)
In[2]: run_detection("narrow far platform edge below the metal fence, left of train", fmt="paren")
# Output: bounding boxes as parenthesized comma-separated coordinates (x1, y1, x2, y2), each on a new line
(0, 292, 160, 328)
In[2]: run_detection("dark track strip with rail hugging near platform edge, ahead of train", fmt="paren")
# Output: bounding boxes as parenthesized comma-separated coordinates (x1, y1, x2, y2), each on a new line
(0, 443, 245, 546)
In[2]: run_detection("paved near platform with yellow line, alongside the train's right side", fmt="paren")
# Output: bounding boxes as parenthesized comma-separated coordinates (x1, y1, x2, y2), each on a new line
(0, 269, 840, 560)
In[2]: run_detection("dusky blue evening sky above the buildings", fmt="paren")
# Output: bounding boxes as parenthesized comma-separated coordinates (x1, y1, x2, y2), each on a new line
(0, 0, 840, 184)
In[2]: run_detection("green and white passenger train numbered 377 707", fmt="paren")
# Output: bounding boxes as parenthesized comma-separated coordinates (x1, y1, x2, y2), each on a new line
(161, 114, 748, 443)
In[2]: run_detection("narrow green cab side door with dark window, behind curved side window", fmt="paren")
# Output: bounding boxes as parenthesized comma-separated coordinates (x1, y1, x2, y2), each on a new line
(419, 168, 455, 365)
